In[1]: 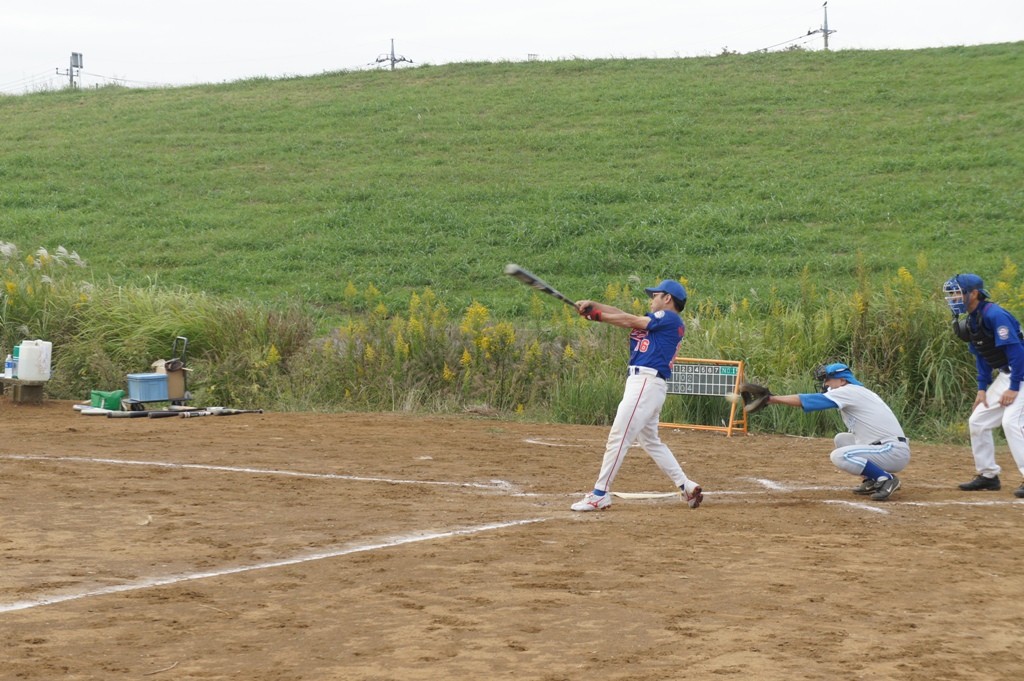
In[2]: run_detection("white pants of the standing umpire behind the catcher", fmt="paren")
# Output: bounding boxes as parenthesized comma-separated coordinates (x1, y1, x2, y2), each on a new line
(968, 372, 1024, 477)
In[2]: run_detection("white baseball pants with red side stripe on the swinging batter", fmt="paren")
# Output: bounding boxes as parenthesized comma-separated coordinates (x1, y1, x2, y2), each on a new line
(594, 369, 694, 493)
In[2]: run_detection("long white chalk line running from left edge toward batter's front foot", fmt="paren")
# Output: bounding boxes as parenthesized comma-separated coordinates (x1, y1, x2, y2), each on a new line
(0, 518, 551, 612)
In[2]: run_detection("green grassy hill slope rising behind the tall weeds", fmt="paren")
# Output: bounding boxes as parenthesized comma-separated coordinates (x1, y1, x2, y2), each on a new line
(0, 43, 1024, 314)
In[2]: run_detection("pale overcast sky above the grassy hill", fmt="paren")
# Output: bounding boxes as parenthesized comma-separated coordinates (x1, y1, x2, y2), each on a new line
(0, 0, 1024, 93)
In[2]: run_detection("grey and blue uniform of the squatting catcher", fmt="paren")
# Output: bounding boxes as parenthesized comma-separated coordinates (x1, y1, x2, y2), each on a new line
(800, 382, 910, 478)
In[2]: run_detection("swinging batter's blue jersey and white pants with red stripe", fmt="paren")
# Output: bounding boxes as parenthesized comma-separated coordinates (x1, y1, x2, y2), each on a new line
(594, 309, 697, 493)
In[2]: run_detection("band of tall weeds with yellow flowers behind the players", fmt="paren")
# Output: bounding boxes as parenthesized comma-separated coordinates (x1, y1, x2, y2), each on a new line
(6, 238, 1024, 440)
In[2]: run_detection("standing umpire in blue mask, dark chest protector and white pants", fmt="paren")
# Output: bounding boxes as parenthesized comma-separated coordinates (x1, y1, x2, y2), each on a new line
(942, 274, 1024, 499)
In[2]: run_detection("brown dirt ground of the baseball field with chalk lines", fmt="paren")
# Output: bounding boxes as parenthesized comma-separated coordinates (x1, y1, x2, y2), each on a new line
(0, 396, 1024, 681)
